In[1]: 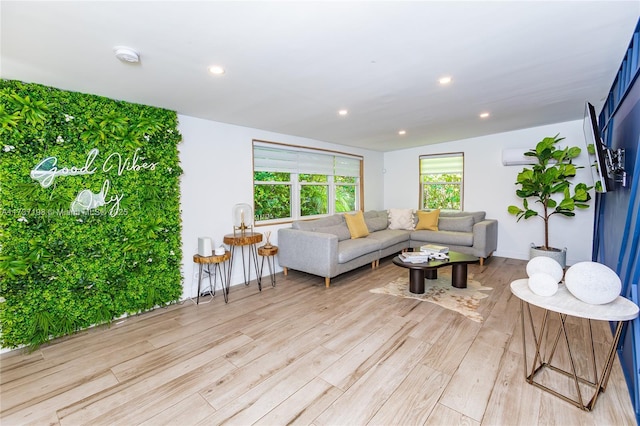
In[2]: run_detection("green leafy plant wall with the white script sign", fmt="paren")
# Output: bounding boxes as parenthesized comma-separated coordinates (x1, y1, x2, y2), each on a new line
(0, 80, 182, 347)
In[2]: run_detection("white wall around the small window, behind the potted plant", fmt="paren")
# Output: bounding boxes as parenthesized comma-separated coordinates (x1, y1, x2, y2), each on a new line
(384, 120, 595, 265)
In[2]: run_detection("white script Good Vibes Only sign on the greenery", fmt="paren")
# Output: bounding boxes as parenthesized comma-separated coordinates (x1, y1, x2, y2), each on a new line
(31, 148, 158, 216)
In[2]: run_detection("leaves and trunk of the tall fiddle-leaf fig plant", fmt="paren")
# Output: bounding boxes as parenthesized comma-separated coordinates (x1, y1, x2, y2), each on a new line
(508, 135, 592, 250)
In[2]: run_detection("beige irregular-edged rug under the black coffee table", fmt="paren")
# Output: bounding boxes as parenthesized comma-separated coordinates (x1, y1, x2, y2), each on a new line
(369, 272, 493, 322)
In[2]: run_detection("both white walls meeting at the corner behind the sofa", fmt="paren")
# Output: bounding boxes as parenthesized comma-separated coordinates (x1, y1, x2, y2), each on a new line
(179, 115, 595, 297)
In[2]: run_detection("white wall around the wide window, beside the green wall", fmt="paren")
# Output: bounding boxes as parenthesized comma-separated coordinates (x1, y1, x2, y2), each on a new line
(178, 115, 384, 298)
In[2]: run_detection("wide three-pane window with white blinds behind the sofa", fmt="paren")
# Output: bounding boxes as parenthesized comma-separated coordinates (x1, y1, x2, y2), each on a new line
(253, 140, 362, 224)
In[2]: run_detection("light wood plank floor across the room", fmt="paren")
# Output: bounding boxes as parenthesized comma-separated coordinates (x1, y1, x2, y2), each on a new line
(0, 257, 636, 426)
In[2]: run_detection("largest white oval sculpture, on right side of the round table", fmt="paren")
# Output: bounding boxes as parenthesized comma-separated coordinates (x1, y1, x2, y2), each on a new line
(564, 262, 622, 305)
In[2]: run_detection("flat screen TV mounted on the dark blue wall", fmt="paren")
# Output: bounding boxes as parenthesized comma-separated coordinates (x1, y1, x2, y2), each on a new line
(583, 102, 613, 192)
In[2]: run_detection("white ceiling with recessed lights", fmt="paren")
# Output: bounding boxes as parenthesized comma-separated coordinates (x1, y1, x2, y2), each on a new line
(0, 0, 640, 151)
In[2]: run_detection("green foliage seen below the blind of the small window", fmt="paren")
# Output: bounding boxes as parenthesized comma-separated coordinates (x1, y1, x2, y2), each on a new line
(422, 174, 462, 210)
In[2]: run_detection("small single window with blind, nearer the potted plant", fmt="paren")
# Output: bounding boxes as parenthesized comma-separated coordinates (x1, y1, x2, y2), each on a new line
(420, 152, 464, 210)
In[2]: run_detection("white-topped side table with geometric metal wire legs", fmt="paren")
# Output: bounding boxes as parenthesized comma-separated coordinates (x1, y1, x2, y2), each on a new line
(511, 279, 638, 411)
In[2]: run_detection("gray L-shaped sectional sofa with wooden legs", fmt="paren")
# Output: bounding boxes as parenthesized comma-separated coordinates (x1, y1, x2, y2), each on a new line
(278, 210, 498, 287)
